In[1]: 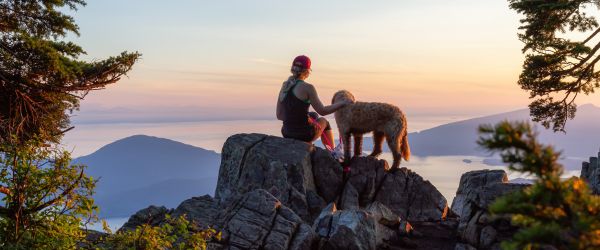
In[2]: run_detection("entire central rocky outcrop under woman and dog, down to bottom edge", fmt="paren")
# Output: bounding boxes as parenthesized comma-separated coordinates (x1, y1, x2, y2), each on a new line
(119, 134, 448, 249)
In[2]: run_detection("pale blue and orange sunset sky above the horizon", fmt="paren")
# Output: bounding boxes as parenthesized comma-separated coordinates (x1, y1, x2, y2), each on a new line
(67, 0, 600, 126)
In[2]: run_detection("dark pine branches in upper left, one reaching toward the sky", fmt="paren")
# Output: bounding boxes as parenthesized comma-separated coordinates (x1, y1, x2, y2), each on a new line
(0, 0, 140, 144)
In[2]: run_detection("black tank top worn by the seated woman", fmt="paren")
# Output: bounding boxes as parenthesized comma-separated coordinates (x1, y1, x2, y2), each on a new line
(281, 80, 310, 135)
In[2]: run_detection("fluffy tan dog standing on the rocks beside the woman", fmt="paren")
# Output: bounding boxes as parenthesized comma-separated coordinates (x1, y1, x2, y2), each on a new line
(331, 90, 410, 170)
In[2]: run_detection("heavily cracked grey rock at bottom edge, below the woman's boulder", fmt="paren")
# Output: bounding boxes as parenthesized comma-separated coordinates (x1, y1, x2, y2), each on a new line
(216, 189, 315, 249)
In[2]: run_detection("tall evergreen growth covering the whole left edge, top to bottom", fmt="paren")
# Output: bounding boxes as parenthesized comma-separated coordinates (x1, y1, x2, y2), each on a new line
(0, 0, 140, 246)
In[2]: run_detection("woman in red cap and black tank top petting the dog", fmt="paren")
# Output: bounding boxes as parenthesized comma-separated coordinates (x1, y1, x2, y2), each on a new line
(277, 55, 350, 150)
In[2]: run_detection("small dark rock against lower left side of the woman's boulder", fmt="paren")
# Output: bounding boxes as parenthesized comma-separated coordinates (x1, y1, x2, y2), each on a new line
(171, 195, 218, 229)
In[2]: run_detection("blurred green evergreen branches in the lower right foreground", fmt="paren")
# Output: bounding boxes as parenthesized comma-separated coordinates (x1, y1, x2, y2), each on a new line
(478, 122, 600, 249)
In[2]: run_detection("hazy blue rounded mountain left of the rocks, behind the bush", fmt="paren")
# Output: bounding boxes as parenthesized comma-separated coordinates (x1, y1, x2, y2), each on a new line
(74, 135, 221, 217)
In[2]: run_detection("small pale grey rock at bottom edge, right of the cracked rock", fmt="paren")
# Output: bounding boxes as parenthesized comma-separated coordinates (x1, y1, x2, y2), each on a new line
(313, 204, 377, 250)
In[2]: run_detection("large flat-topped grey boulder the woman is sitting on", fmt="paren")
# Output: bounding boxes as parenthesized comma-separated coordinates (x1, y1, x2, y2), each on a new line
(215, 134, 330, 221)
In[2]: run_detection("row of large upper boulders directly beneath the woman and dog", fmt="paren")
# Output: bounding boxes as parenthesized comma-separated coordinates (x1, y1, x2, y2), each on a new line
(215, 134, 448, 223)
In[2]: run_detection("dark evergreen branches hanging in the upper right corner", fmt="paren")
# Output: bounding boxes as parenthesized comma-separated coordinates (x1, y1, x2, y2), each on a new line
(508, 0, 600, 132)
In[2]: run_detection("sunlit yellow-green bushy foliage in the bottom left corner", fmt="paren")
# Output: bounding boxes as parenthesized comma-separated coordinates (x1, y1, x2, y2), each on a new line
(0, 142, 97, 249)
